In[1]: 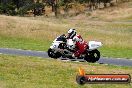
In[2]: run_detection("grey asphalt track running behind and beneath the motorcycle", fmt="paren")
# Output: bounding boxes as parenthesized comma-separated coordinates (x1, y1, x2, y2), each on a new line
(0, 48, 132, 66)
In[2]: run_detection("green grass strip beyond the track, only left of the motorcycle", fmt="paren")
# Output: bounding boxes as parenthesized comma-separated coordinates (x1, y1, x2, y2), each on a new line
(0, 36, 51, 51)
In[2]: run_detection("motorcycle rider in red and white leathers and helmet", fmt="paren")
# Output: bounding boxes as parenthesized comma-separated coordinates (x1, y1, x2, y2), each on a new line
(67, 29, 88, 58)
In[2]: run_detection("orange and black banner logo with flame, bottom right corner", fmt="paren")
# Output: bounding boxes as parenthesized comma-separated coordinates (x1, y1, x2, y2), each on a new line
(76, 68, 131, 85)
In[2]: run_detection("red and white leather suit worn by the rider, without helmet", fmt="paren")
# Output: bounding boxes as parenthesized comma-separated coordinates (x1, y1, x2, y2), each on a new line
(72, 35, 88, 57)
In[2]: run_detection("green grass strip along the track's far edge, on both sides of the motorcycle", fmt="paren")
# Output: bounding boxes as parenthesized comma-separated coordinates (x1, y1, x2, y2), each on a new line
(0, 36, 132, 59)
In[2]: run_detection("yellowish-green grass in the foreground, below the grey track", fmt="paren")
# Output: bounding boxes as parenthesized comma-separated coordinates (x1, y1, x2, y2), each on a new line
(0, 55, 132, 88)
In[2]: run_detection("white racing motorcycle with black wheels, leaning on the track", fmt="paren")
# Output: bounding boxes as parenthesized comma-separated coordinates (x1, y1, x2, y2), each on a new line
(48, 34, 102, 63)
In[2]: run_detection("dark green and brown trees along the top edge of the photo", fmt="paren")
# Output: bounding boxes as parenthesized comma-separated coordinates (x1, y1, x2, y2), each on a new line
(0, 0, 130, 15)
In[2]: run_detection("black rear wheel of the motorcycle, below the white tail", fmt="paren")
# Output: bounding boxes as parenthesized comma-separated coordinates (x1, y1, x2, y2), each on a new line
(84, 49, 100, 63)
